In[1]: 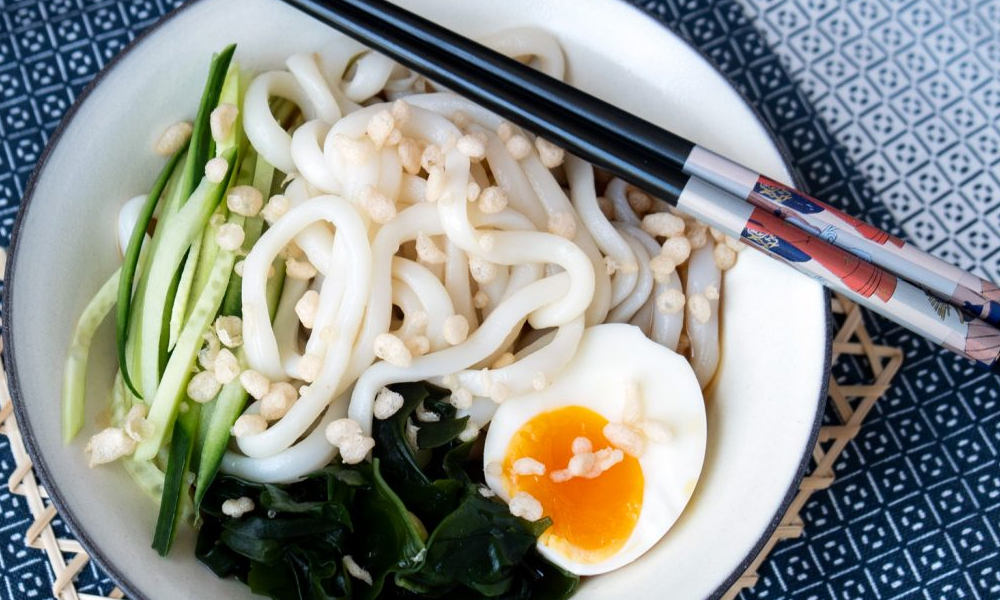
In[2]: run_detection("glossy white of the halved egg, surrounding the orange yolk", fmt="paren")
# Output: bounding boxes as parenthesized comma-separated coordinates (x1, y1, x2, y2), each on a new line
(483, 324, 707, 575)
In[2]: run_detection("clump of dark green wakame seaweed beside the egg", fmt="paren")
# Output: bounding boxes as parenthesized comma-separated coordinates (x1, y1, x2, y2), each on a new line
(196, 383, 579, 600)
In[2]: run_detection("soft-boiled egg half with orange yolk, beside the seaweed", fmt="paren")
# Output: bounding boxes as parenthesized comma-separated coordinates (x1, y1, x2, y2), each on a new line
(483, 324, 706, 575)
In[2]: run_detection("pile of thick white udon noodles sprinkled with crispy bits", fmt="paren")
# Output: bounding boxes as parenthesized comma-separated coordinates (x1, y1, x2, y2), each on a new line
(209, 29, 735, 482)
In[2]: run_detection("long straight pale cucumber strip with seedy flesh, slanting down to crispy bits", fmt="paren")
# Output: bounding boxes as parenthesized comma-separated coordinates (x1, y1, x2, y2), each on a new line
(135, 215, 243, 460)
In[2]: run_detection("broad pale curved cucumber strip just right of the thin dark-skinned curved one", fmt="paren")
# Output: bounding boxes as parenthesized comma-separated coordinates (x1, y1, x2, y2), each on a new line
(139, 149, 238, 397)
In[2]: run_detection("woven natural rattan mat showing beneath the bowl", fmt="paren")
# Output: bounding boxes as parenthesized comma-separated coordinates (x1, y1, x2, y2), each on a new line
(0, 262, 903, 600)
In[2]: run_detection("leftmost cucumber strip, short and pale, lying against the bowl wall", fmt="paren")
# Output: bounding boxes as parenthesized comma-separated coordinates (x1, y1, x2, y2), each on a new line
(62, 268, 122, 444)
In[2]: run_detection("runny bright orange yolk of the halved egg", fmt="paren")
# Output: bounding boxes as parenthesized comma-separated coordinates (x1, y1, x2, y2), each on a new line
(503, 406, 644, 564)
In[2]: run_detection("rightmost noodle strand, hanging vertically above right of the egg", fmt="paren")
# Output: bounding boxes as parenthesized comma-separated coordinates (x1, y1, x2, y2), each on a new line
(684, 240, 722, 389)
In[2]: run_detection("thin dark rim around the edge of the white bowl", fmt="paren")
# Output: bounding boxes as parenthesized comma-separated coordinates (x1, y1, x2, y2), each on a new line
(2, 0, 835, 600)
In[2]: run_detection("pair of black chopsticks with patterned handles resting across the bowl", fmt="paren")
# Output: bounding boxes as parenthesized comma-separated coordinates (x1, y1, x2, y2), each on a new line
(276, 0, 1000, 371)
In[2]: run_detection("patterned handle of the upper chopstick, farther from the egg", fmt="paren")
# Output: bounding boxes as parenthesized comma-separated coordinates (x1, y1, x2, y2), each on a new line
(685, 147, 1000, 325)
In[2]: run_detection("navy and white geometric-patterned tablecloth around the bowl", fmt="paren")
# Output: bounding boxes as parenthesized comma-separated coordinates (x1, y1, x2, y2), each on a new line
(0, 0, 1000, 600)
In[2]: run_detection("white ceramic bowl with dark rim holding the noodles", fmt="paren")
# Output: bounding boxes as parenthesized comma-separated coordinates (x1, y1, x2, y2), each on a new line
(4, 0, 829, 600)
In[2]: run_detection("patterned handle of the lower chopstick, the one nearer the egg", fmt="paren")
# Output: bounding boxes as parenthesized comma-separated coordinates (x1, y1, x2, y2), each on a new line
(677, 178, 1000, 370)
